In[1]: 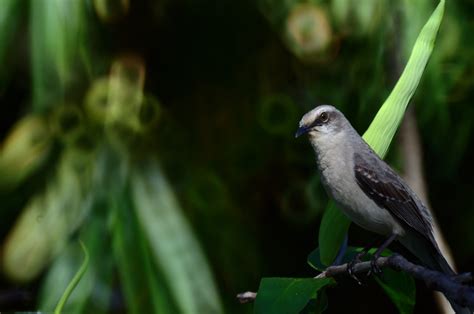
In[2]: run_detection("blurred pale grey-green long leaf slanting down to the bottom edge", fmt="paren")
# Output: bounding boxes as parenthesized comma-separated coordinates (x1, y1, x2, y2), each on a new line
(131, 160, 223, 314)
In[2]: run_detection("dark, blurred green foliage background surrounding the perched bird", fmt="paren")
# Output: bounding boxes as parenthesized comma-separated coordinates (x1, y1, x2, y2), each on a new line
(0, 0, 474, 313)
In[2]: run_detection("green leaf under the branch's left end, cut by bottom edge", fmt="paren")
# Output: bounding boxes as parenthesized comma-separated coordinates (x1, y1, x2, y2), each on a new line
(254, 278, 334, 314)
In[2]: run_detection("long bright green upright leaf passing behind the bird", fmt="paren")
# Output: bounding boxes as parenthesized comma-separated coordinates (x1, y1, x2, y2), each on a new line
(319, 0, 445, 265)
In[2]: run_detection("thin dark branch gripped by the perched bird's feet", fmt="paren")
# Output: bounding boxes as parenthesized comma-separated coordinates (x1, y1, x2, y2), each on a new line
(237, 254, 474, 310)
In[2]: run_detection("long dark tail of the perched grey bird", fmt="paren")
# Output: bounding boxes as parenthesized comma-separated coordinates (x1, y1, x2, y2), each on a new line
(400, 234, 473, 314)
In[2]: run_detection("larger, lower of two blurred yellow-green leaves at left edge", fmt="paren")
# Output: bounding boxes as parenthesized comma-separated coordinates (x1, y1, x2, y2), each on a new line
(3, 148, 99, 282)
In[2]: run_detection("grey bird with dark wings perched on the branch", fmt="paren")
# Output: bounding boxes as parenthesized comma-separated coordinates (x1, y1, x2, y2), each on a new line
(295, 105, 471, 313)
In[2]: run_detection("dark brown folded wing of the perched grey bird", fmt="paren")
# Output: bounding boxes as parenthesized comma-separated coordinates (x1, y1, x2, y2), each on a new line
(354, 153, 434, 241)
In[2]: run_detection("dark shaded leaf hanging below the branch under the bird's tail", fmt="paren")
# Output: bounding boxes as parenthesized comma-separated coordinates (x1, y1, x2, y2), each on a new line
(374, 268, 416, 314)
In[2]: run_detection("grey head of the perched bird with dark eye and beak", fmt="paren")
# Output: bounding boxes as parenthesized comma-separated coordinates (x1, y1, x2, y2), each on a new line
(295, 105, 348, 139)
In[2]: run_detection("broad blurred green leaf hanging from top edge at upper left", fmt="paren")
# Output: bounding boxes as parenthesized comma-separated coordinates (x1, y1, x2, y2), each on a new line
(30, 0, 87, 111)
